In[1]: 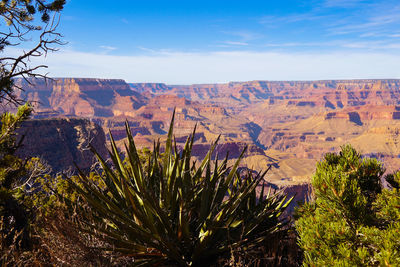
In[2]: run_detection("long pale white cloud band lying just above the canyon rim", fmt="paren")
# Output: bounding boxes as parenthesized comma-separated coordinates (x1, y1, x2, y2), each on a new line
(7, 47, 400, 84)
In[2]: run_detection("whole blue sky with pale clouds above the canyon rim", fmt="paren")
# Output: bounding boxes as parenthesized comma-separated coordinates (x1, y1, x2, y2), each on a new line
(12, 0, 400, 84)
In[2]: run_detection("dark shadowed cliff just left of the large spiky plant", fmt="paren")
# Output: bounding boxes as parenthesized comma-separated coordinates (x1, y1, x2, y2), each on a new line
(17, 118, 108, 173)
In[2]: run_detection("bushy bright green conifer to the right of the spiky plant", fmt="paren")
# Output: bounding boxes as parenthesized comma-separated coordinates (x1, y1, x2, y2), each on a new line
(296, 145, 400, 266)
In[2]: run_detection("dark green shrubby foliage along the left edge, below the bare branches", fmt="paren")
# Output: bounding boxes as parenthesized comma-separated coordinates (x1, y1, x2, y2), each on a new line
(0, 104, 52, 266)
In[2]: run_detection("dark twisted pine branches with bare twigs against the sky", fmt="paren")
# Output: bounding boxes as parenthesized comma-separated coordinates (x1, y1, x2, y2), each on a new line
(0, 0, 65, 105)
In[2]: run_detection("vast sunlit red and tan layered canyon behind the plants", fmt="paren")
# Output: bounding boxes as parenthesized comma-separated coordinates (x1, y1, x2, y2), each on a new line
(10, 78, 400, 191)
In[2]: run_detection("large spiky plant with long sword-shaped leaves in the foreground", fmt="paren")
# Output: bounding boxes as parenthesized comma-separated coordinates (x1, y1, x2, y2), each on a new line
(71, 112, 291, 266)
